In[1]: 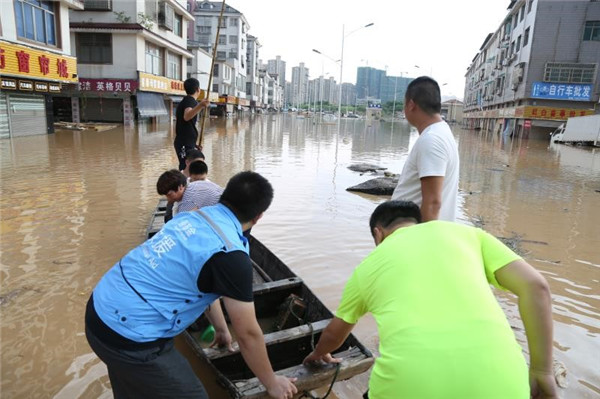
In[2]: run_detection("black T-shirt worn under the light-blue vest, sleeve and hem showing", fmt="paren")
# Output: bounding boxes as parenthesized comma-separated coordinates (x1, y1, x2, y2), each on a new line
(85, 251, 254, 350)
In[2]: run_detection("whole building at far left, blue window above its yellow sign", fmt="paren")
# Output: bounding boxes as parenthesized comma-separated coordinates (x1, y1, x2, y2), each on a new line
(0, 0, 83, 138)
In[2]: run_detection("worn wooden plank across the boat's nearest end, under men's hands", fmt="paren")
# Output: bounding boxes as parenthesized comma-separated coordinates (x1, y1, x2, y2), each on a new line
(233, 347, 375, 399)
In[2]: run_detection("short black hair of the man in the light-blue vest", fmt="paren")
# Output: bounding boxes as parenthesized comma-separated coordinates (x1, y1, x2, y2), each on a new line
(219, 171, 273, 223)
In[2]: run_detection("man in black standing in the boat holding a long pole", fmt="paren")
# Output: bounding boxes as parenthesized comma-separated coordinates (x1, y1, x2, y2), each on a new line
(174, 78, 210, 170)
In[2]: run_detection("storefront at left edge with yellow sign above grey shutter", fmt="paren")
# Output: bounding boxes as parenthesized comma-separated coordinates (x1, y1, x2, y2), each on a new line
(0, 40, 77, 138)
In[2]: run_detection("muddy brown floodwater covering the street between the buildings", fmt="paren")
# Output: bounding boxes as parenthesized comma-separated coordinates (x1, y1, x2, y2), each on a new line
(0, 115, 600, 399)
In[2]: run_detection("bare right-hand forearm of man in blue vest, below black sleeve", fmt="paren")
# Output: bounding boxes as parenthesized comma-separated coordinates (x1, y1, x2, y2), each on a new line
(223, 297, 297, 398)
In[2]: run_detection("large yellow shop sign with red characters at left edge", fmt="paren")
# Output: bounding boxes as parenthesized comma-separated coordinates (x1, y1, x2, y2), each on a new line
(0, 40, 77, 83)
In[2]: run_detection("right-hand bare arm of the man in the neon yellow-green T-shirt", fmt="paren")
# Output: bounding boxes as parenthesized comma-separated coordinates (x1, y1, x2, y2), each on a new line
(494, 259, 557, 398)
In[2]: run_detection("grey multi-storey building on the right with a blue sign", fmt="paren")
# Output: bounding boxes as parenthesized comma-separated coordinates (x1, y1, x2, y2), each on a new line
(464, 0, 600, 137)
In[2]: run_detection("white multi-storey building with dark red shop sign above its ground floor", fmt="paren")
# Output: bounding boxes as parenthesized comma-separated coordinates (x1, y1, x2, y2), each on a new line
(70, 0, 193, 126)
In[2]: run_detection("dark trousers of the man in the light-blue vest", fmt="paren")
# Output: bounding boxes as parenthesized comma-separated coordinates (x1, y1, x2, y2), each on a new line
(85, 328, 208, 399)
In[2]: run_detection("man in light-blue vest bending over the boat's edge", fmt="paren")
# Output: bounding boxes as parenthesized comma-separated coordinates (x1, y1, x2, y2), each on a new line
(85, 172, 297, 399)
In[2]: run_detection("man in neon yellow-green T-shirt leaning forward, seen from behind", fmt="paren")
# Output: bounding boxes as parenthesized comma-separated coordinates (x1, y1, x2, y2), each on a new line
(304, 201, 557, 399)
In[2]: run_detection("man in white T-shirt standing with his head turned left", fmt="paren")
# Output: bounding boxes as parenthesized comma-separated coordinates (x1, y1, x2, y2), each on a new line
(392, 76, 459, 222)
